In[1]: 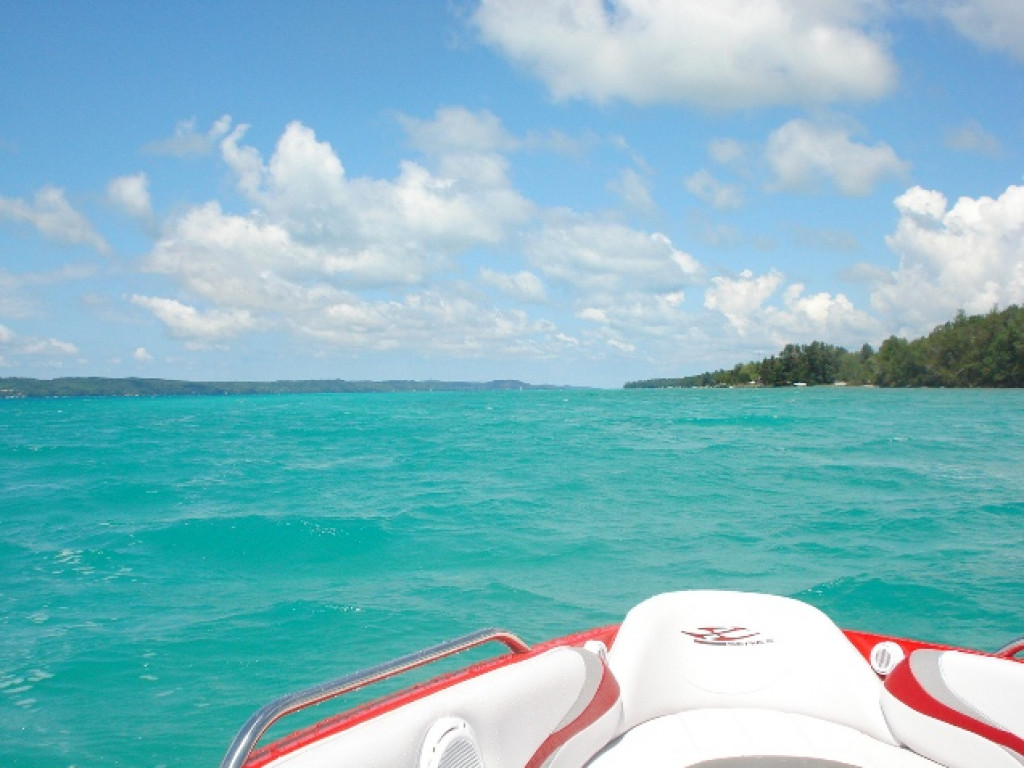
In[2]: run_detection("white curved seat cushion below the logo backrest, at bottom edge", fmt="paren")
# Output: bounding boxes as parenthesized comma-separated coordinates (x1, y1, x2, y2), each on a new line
(587, 709, 937, 768)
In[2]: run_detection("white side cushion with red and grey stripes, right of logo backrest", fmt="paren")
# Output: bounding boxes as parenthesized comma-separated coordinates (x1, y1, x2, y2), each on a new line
(882, 649, 1024, 768)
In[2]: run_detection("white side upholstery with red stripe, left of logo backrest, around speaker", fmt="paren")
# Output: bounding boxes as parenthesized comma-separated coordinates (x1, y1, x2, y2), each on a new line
(267, 647, 622, 768)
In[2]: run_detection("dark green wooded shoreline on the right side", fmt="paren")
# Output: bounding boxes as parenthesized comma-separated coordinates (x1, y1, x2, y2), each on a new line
(626, 305, 1024, 389)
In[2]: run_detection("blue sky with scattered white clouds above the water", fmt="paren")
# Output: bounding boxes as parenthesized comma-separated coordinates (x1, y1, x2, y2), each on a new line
(0, 0, 1024, 387)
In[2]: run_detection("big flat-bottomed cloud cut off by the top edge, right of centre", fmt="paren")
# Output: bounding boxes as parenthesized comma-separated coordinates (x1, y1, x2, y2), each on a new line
(474, 0, 896, 110)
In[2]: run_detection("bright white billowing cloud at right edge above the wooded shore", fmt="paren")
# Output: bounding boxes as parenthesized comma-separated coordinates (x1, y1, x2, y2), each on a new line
(871, 186, 1024, 335)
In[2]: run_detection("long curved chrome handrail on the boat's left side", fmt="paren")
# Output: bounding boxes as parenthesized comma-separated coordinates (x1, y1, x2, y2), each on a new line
(220, 628, 529, 768)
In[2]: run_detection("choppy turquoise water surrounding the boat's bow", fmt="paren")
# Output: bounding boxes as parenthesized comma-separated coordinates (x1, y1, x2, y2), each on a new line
(0, 388, 1024, 768)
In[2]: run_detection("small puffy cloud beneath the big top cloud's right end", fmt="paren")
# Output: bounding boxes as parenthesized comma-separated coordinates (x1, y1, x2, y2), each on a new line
(765, 120, 909, 196)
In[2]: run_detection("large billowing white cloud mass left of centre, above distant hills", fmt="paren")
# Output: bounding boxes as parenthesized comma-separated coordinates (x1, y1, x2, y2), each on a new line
(133, 115, 561, 354)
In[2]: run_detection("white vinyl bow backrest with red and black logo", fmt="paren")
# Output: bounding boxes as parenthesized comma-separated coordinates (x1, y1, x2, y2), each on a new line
(608, 591, 901, 741)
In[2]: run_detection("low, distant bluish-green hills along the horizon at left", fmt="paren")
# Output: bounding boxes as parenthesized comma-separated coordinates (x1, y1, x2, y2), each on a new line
(0, 377, 566, 398)
